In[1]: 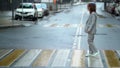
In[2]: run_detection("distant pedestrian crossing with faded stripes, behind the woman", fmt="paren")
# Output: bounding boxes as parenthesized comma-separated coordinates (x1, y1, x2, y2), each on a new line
(43, 23, 120, 28)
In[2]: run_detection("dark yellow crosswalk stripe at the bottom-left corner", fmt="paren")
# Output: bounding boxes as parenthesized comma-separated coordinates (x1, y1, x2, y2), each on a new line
(0, 49, 25, 67)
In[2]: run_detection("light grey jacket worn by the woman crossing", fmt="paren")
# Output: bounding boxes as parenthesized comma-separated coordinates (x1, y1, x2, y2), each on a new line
(85, 12, 97, 34)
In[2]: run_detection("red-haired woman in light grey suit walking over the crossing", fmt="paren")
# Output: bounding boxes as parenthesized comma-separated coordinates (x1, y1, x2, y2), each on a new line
(85, 3, 98, 57)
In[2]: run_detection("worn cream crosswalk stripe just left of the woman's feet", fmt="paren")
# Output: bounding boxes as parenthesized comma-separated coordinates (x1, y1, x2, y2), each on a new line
(71, 50, 85, 68)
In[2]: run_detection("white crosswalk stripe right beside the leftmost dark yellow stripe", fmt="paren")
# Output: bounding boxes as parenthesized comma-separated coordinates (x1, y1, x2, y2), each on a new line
(13, 49, 41, 67)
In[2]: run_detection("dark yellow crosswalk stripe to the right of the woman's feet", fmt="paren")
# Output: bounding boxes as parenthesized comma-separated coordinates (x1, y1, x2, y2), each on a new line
(104, 50, 120, 68)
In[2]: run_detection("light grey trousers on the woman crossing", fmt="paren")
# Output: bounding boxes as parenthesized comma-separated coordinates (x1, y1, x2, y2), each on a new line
(88, 34, 97, 54)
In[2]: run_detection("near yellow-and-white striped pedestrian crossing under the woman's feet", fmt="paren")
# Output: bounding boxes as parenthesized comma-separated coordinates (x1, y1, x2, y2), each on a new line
(0, 49, 120, 68)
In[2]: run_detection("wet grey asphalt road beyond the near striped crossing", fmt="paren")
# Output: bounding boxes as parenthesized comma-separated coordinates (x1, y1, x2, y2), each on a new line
(0, 4, 120, 50)
